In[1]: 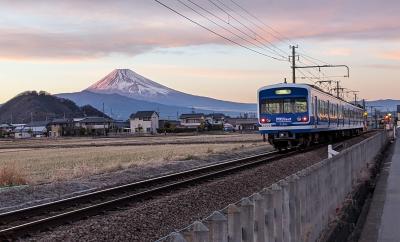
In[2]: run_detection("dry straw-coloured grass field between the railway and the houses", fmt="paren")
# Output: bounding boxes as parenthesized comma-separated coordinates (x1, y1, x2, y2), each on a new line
(0, 142, 263, 187)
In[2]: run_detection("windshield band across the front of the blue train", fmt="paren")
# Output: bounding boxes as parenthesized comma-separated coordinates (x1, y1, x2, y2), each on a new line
(260, 98, 307, 114)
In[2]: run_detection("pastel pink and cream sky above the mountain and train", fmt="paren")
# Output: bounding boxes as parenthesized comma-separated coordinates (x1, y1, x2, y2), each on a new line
(0, 0, 400, 103)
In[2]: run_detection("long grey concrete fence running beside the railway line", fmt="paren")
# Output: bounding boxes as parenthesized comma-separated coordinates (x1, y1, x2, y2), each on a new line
(158, 132, 388, 242)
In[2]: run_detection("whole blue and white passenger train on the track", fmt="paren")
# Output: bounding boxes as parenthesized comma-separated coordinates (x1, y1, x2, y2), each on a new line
(257, 83, 365, 150)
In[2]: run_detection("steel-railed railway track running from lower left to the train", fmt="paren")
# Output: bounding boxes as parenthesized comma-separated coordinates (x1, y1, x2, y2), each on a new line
(0, 150, 297, 241)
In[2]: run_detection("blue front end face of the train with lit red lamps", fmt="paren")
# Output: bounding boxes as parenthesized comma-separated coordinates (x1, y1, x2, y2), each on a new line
(258, 83, 314, 150)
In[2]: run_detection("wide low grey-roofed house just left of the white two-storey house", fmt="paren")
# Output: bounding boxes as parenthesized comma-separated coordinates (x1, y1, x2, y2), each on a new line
(74, 117, 113, 135)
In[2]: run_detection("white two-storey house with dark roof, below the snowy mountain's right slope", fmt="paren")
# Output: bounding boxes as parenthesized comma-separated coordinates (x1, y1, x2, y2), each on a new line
(129, 111, 160, 134)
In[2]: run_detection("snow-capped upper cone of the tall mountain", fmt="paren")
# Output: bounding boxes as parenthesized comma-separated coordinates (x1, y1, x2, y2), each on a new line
(86, 69, 174, 97)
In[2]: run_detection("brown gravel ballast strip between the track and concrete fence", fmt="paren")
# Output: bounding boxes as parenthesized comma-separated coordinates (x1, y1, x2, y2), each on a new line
(26, 133, 372, 242)
